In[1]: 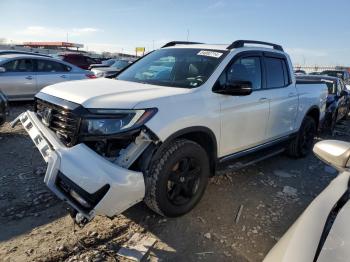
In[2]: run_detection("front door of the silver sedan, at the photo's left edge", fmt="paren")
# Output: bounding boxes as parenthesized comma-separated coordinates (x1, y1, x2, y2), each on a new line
(0, 59, 36, 100)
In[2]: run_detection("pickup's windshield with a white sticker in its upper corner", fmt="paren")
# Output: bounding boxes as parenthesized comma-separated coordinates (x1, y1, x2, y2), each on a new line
(118, 48, 227, 88)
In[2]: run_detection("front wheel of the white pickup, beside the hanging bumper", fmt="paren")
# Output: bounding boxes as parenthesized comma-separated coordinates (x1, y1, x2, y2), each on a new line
(144, 139, 210, 217)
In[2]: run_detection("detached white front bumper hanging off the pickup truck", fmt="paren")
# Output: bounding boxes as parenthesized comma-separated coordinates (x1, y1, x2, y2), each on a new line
(12, 111, 145, 223)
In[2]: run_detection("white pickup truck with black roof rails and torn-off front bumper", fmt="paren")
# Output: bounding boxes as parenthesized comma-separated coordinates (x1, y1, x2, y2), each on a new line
(13, 40, 327, 223)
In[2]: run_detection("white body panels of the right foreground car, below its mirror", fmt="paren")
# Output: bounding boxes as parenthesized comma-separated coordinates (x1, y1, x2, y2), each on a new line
(264, 172, 350, 262)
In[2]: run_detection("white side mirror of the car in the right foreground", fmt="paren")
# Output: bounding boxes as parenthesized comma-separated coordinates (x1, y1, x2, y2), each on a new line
(313, 140, 350, 171)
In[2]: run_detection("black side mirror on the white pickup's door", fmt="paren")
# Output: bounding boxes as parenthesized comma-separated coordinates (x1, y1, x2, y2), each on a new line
(214, 81, 253, 96)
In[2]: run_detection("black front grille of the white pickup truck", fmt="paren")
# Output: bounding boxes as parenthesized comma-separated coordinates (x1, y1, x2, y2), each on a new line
(35, 99, 80, 147)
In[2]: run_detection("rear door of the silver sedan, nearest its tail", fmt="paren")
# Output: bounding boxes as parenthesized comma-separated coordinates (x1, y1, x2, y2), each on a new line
(35, 59, 71, 92)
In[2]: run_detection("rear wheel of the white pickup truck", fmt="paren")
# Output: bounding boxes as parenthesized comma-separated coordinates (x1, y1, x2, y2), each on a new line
(287, 116, 317, 158)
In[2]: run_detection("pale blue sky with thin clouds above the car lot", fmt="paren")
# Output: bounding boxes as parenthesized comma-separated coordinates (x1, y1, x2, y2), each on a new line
(0, 0, 350, 66)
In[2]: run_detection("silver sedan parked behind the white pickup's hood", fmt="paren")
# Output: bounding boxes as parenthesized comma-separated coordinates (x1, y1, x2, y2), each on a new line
(0, 54, 96, 101)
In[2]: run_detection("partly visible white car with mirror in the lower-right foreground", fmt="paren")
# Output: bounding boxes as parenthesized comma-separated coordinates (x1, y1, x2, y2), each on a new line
(264, 140, 350, 262)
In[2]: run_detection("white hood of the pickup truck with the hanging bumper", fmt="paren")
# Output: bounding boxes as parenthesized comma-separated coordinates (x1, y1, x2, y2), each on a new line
(41, 78, 191, 109)
